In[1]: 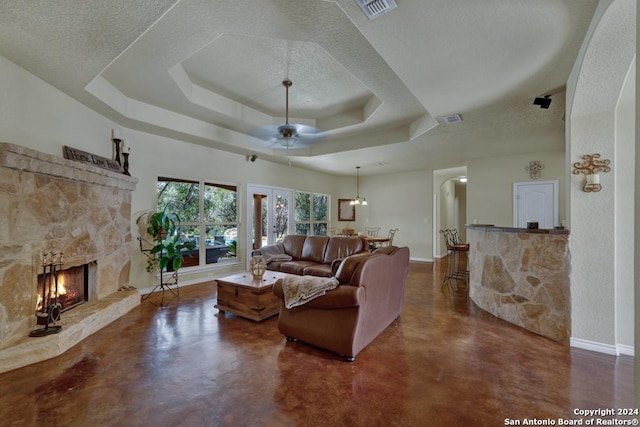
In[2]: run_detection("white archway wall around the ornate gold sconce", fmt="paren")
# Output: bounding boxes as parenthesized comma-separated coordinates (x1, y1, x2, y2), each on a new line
(566, 0, 636, 353)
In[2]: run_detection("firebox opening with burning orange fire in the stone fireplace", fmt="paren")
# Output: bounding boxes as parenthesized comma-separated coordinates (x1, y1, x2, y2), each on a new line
(36, 264, 89, 312)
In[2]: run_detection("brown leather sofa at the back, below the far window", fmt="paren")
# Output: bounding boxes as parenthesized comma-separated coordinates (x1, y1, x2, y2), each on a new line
(253, 234, 369, 277)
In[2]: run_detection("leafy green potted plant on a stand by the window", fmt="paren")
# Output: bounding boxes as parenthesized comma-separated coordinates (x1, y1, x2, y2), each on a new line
(136, 211, 195, 272)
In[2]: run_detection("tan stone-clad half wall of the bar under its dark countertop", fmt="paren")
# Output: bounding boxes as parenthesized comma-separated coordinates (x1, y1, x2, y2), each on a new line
(467, 227, 571, 344)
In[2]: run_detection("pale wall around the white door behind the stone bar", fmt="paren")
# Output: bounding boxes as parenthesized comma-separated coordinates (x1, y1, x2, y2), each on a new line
(467, 151, 566, 227)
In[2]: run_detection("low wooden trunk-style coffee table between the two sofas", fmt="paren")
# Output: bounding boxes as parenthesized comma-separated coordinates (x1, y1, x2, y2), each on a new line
(216, 270, 291, 322)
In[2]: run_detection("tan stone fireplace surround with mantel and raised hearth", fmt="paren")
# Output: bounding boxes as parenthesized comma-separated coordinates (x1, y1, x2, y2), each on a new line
(0, 143, 140, 372)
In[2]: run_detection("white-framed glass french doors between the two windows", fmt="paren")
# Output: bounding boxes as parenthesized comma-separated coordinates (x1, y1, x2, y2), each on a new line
(246, 184, 293, 262)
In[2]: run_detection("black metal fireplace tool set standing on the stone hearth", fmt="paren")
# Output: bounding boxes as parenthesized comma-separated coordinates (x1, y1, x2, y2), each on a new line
(29, 252, 63, 337)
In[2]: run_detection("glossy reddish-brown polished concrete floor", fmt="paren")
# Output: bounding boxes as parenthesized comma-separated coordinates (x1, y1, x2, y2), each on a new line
(0, 263, 633, 426)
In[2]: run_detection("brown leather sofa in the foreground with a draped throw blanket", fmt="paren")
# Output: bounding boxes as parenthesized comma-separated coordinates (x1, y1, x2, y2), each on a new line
(273, 246, 409, 361)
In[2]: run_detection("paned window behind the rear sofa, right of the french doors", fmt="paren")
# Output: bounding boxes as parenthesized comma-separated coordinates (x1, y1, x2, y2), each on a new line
(295, 191, 329, 236)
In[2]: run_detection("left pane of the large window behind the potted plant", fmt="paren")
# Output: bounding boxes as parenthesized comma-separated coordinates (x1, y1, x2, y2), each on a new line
(157, 178, 200, 222)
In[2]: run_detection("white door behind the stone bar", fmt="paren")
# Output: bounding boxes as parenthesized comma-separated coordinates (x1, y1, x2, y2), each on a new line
(513, 181, 558, 229)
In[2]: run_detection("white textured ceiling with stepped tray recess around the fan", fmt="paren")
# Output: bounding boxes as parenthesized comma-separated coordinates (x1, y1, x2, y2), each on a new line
(0, 0, 597, 175)
